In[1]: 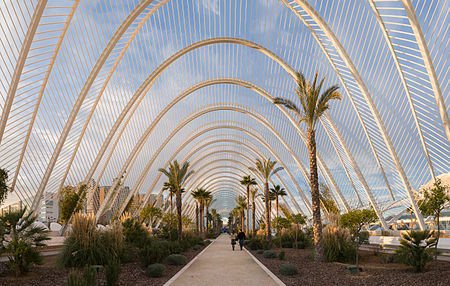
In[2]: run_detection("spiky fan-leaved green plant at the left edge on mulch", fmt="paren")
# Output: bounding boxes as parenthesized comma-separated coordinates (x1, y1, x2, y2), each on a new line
(0, 208, 49, 275)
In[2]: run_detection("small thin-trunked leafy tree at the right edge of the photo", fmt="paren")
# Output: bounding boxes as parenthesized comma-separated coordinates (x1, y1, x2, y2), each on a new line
(419, 179, 450, 260)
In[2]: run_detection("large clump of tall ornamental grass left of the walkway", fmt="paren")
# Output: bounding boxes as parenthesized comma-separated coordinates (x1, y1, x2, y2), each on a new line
(58, 214, 125, 268)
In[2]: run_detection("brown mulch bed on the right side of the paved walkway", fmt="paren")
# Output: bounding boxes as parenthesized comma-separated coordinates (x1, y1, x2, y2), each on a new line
(251, 249, 450, 286)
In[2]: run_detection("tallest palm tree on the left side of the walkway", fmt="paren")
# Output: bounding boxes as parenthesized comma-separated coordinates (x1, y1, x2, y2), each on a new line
(159, 160, 194, 240)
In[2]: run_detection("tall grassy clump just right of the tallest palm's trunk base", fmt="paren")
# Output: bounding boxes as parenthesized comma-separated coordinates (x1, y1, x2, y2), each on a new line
(323, 225, 356, 262)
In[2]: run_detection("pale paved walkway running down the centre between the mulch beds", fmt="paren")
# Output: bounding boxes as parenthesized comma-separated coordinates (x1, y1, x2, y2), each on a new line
(166, 235, 283, 286)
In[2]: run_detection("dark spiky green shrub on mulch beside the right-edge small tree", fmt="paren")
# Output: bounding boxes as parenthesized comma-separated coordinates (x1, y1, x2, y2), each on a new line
(395, 230, 436, 272)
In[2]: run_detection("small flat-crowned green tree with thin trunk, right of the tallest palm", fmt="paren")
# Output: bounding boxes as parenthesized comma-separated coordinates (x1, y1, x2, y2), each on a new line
(339, 209, 377, 271)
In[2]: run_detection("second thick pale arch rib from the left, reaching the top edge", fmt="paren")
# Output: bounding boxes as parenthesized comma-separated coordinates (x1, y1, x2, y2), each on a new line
(31, 0, 157, 213)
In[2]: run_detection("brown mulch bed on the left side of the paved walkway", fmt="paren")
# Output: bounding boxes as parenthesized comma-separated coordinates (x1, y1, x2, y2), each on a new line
(0, 248, 203, 286)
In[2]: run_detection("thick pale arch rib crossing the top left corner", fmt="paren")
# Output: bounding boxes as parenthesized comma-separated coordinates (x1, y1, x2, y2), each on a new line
(0, 0, 48, 143)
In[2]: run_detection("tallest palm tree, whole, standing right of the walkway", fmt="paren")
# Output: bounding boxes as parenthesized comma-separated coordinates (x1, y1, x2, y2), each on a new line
(273, 72, 341, 261)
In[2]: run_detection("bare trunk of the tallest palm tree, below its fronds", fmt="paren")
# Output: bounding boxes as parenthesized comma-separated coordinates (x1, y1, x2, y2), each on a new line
(308, 128, 323, 262)
